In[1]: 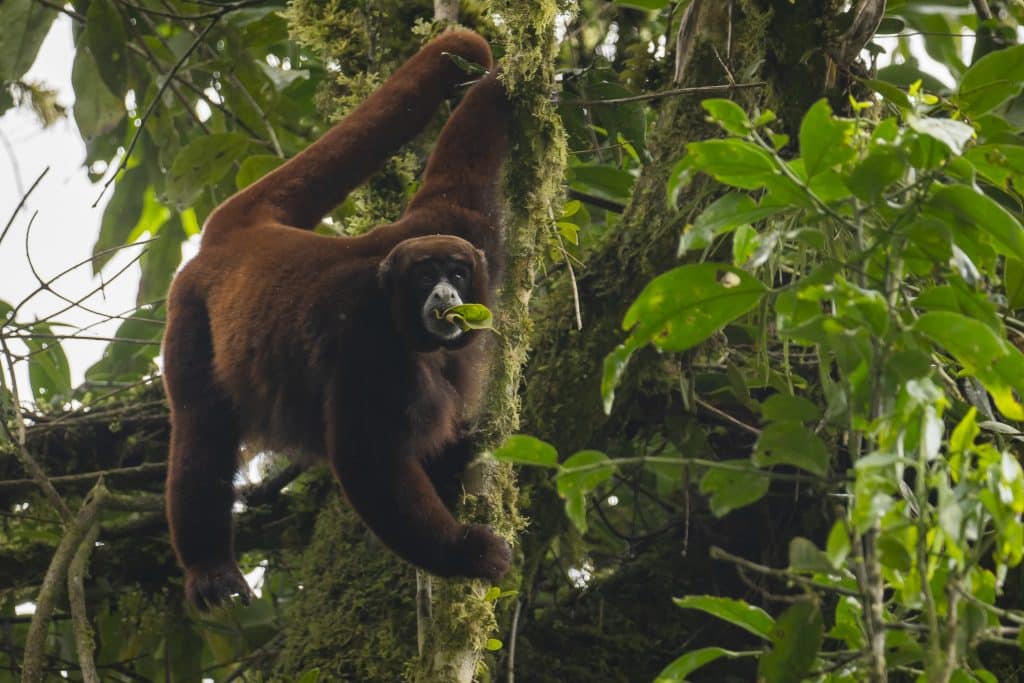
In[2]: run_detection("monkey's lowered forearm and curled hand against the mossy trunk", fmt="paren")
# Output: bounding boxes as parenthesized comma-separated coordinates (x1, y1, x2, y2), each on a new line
(334, 452, 511, 582)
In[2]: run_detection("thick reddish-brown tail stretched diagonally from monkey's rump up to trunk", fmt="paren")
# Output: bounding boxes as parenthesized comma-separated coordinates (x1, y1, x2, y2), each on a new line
(203, 31, 492, 243)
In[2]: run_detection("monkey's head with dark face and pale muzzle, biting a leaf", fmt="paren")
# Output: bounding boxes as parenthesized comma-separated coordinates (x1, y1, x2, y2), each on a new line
(378, 234, 489, 351)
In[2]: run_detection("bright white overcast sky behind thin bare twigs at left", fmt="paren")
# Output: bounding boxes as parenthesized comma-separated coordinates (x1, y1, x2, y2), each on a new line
(0, 14, 139, 384)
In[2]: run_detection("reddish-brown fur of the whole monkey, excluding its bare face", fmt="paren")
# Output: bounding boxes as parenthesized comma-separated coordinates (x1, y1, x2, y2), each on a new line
(163, 31, 510, 607)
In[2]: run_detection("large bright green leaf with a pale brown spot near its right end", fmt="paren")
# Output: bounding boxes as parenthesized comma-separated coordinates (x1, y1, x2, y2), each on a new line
(623, 263, 766, 351)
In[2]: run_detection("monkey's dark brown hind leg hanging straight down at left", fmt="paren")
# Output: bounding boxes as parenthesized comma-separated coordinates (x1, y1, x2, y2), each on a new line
(163, 297, 251, 609)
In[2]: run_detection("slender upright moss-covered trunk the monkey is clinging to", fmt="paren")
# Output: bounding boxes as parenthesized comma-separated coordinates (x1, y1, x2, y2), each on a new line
(414, 0, 565, 683)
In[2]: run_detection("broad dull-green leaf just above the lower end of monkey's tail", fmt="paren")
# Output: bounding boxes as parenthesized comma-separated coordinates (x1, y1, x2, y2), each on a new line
(164, 133, 249, 209)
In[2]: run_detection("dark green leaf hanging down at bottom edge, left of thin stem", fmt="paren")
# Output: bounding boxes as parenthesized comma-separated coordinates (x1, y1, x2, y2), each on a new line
(758, 600, 824, 683)
